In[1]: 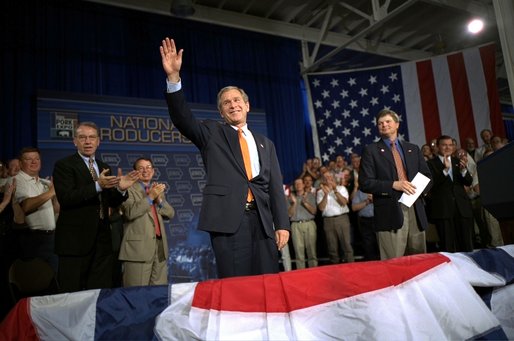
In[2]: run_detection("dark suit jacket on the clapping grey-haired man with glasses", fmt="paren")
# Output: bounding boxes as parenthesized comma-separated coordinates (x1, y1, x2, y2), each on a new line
(53, 153, 127, 256)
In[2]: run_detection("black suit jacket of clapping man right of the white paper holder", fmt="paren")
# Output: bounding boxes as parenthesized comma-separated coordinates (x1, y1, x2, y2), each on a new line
(428, 156, 473, 219)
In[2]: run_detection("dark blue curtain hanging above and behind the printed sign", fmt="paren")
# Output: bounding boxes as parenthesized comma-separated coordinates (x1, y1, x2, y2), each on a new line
(0, 0, 313, 182)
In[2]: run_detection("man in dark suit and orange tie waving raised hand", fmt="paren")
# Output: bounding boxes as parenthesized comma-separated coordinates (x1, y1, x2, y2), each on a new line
(160, 38, 290, 278)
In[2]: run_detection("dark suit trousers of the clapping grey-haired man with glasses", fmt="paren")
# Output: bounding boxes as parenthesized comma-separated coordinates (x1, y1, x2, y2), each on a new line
(58, 219, 114, 292)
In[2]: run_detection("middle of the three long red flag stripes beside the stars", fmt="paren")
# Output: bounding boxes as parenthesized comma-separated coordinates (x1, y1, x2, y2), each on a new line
(446, 53, 476, 142)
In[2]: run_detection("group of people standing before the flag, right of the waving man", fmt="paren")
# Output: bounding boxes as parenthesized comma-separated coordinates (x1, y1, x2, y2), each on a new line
(285, 124, 512, 269)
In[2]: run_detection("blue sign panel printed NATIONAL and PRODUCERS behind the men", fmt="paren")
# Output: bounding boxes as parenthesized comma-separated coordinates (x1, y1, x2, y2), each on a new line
(37, 92, 267, 283)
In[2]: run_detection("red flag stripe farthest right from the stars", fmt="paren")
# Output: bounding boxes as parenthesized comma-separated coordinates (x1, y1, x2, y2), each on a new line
(479, 44, 505, 136)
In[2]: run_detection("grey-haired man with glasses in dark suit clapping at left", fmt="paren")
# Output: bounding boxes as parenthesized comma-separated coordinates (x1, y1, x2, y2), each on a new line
(53, 122, 139, 292)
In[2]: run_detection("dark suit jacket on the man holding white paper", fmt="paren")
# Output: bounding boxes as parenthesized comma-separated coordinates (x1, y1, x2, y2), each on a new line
(359, 140, 432, 231)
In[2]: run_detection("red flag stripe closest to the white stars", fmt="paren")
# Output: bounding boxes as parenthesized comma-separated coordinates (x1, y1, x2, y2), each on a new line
(416, 60, 441, 141)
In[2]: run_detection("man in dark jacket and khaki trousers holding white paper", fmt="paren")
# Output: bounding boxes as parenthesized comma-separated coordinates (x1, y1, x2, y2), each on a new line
(359, 109, 432, 259)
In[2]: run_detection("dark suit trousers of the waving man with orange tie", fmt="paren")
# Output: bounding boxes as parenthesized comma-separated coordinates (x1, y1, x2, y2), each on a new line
(211, 210, 279, 278)
